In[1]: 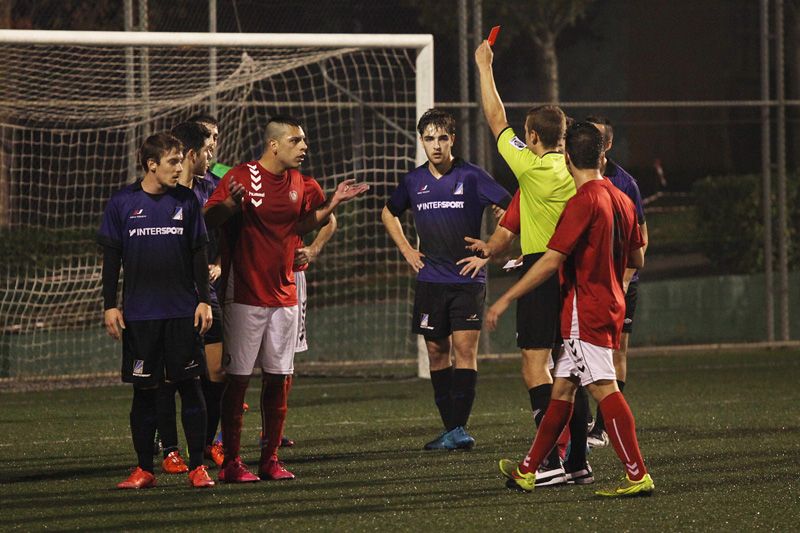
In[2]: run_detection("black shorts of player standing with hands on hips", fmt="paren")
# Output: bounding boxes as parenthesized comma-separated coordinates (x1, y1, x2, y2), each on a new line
(411, 281, 486, 339)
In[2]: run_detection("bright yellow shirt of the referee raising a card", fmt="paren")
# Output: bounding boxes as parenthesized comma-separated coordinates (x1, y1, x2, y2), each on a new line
(497, 128, 575, 255)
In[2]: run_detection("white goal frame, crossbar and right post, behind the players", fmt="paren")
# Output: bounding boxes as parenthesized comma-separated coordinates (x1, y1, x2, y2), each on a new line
(0, 30, 434, 378)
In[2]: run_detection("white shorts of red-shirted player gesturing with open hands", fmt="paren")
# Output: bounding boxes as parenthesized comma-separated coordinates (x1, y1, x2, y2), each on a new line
(222, 303, 300, 376)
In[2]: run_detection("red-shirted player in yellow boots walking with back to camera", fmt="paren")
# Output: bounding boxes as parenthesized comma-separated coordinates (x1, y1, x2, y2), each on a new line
(487, 122, 654, 496)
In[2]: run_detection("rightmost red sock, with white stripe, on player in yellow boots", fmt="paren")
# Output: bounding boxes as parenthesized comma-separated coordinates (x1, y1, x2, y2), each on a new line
(600, 392, 647, 481)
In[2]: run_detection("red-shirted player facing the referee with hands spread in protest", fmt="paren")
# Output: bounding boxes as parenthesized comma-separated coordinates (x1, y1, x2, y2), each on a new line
(205, 116, 369, 483)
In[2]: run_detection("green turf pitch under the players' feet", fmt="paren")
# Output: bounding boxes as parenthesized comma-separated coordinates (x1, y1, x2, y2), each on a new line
(0, 350, 800, 531)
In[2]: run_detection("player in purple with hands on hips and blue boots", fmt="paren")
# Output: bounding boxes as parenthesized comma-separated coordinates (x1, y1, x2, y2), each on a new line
(381, 109, 511, 450)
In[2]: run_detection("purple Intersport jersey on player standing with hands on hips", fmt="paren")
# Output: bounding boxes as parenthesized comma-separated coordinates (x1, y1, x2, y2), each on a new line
(386, 159, 511, 283)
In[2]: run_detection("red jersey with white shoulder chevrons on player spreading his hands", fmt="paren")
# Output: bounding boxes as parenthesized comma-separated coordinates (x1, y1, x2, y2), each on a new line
(206, 161, 324, 307)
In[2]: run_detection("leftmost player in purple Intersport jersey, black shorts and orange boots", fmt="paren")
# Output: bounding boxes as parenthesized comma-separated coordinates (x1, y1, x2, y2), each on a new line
(98, 133, 214, 489)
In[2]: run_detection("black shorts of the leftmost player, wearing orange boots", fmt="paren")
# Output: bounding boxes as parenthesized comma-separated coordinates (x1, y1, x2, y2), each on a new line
(122, 317, 206, 387)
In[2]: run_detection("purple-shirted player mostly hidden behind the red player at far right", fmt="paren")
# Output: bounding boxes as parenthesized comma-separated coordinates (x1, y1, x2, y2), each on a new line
(586, 115, 649, 448)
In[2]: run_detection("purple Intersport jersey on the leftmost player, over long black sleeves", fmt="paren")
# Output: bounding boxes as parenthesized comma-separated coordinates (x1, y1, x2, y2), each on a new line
(97, 182, 208, 320)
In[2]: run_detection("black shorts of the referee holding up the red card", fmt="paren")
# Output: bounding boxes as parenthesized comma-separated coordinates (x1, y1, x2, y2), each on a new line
(517, 253, 561, 350)
